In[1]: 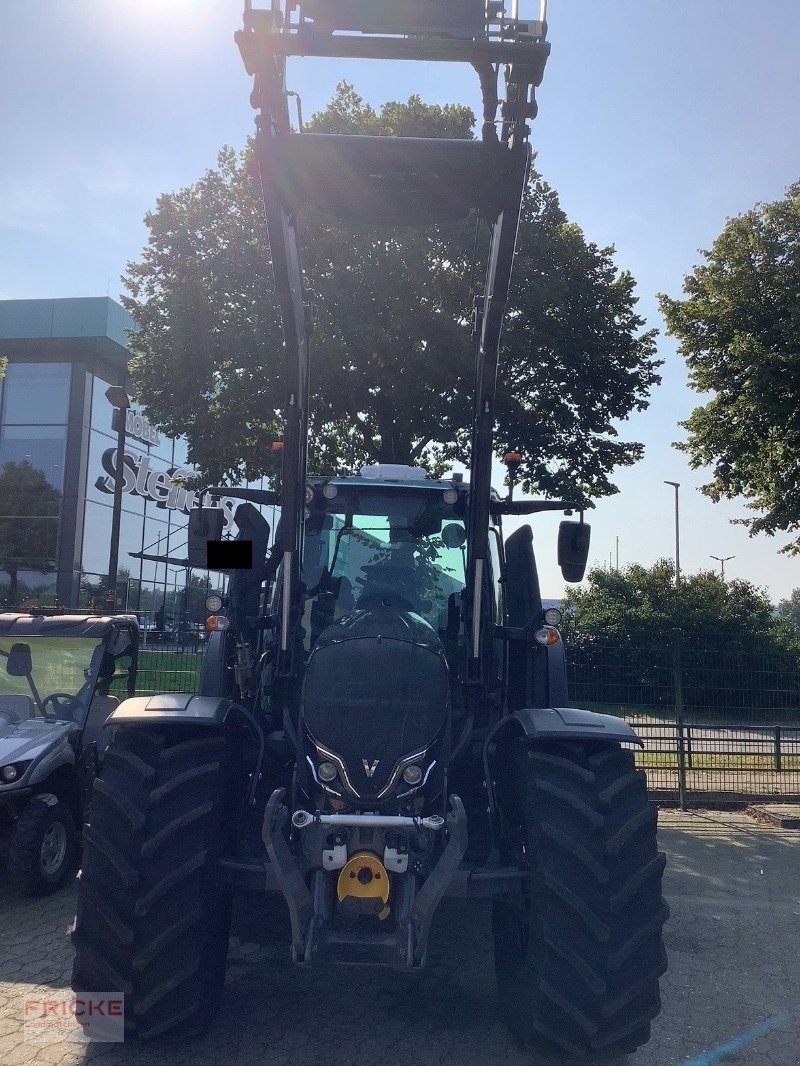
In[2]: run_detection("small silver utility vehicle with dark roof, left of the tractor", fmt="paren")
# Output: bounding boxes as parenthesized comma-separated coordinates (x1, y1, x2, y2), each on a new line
(0, 614, 139, 895)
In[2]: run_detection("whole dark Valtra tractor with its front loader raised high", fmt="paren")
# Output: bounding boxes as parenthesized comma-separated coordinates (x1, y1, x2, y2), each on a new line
(74, 0, 668, 1057)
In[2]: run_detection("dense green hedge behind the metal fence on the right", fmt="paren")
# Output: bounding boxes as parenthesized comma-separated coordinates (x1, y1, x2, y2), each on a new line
(563, 560, 800, 724)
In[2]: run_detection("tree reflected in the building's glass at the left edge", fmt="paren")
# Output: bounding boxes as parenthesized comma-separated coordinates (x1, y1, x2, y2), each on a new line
(0, 459, 61, 605)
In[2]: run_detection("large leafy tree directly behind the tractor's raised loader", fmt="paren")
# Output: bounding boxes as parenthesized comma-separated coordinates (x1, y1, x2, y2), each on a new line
(124, 84, 658, 496)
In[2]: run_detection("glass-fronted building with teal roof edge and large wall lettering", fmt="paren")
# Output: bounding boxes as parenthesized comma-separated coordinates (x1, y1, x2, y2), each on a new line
(0, 297, 260, 628)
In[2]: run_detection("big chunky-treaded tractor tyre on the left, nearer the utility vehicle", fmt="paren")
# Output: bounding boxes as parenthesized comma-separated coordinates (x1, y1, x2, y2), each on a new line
(73, 726, 237, 1039)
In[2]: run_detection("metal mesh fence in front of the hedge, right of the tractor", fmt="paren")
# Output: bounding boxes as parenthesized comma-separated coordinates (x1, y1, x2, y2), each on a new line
(567, 630, 800, 806)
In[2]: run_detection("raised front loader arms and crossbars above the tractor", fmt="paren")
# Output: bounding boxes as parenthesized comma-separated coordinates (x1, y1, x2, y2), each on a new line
(236, 0, 549, 702)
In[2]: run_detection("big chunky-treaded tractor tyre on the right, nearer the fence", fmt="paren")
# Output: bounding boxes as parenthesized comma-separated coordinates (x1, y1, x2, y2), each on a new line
(492, 741, 669, 1059)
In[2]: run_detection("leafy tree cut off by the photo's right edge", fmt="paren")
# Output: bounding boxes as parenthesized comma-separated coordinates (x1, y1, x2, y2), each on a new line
(660, 182, 800, 554)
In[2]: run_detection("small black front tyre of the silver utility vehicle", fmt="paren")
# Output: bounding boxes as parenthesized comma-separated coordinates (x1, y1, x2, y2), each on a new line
(9, 796, 78, 895)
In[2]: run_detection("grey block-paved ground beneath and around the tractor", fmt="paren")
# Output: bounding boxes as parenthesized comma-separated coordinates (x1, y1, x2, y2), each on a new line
(0, 811, 800, 1066)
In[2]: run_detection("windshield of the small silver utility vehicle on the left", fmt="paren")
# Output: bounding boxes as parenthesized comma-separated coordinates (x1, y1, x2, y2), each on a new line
(0, 635, 102, 725)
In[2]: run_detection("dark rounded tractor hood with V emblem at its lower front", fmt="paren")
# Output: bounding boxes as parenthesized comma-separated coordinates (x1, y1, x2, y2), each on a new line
(303, 608, 449, 801)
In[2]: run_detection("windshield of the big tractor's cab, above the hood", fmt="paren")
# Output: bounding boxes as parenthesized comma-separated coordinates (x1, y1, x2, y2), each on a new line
(303, 488, 466, 651)
